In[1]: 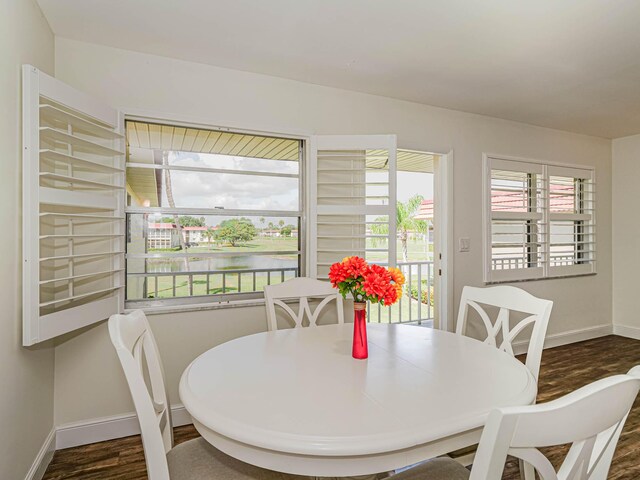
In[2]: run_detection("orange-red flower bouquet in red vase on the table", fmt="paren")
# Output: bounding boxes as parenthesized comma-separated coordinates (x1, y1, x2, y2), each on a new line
(329, 256, 404, 359)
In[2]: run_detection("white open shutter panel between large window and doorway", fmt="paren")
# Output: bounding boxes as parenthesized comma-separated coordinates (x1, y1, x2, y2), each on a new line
(309, 135, 396, 279)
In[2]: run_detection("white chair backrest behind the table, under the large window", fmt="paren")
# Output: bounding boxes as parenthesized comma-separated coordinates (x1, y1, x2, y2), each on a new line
(264, 277, 344, 331)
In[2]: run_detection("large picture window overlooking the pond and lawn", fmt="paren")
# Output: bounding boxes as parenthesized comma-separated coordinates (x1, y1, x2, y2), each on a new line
(126, 121, 304, 308)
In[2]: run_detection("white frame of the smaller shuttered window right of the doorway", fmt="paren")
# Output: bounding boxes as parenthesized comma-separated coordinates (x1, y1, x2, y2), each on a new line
(482, 153, 597, 284)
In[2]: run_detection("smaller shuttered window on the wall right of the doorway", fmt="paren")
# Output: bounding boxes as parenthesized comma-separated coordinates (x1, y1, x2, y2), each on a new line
(485, 156, 596, 282)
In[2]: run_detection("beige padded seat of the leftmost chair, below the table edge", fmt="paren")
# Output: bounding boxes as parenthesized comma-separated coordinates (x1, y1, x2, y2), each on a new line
(167, 437, 309, 480)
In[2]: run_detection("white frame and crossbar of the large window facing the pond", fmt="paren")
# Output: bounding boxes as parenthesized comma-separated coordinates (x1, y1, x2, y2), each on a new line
(122, 114, 309, 313)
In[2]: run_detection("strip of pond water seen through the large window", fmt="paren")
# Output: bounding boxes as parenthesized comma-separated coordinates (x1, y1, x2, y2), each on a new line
(141, 255, 298, 273)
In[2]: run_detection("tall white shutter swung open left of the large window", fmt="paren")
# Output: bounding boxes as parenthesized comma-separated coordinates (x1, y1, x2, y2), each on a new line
(22, 65, 125, 345)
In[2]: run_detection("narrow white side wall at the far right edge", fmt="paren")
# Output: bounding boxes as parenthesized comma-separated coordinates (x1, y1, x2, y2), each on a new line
(612, 135, 640, 338)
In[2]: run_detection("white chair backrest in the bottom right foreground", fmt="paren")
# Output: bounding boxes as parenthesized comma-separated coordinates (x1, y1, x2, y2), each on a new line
(470, 366, 640, 480)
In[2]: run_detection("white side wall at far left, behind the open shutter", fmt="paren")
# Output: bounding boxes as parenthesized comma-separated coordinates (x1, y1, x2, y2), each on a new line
(0, 0, 54, 480)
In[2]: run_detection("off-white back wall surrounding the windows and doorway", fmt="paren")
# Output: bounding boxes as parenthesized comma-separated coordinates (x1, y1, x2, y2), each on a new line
(55, 38, 612, 424)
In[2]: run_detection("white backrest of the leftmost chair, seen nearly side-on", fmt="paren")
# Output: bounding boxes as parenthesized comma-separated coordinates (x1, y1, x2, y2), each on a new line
(109, 310, 173, 480)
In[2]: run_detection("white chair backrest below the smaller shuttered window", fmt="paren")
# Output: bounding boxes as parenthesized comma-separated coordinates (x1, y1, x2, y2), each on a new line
(456, 285, 553, 380)
